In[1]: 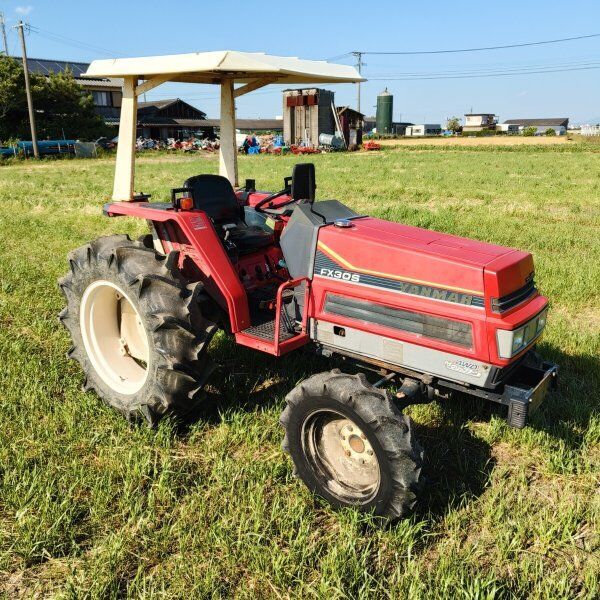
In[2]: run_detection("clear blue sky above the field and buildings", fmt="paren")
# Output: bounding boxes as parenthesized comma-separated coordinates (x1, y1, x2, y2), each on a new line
(0, 0, 600, 123)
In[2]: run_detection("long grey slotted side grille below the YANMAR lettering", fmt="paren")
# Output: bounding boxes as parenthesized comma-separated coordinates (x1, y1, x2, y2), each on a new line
(325, 294, 473, 348)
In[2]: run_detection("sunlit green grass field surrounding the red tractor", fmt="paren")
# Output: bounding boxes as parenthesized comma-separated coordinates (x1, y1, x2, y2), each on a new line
(0, 145, 600, 599)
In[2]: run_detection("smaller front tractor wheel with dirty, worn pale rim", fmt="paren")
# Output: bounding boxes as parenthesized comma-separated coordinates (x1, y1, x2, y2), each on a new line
(280, 369, 423, 519)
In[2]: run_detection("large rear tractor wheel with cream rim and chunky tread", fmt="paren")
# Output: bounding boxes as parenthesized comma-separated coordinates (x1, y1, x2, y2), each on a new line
(59, 235, 216, 425)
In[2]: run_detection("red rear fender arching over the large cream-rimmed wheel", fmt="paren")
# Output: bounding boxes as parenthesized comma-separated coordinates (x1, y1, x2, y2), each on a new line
(104, 202, 250, 333)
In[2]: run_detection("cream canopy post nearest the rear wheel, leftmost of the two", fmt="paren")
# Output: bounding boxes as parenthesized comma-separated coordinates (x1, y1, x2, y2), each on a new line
(113, 77, 137, 202)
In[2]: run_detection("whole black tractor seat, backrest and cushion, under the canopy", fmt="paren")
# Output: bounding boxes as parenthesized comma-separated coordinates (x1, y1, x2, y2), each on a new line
(183, 175, 275, 254)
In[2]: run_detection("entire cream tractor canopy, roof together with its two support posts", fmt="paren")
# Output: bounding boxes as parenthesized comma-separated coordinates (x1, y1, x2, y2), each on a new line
(86, 51, 364, 202)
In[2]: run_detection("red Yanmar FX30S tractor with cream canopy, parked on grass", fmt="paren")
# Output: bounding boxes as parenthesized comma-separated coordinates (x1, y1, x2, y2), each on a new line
(60, 52, 557, 518)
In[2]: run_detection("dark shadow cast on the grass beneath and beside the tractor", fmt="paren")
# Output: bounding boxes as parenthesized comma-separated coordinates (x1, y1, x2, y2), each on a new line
(180, 339, 600, 519)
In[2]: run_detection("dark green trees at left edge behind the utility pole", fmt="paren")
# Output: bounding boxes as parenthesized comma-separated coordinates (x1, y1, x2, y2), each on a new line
(0, 56, 106, 140)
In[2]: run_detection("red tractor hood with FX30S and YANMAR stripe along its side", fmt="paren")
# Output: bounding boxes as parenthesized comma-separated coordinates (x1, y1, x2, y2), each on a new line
(314, 217, 533, 307)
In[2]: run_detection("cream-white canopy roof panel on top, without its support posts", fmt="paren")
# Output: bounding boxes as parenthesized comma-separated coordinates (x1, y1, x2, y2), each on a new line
(85, 50, 365, 84)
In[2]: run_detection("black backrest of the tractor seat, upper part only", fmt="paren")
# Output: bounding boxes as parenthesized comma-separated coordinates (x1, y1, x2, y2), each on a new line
(183, 174, 242, 223)
